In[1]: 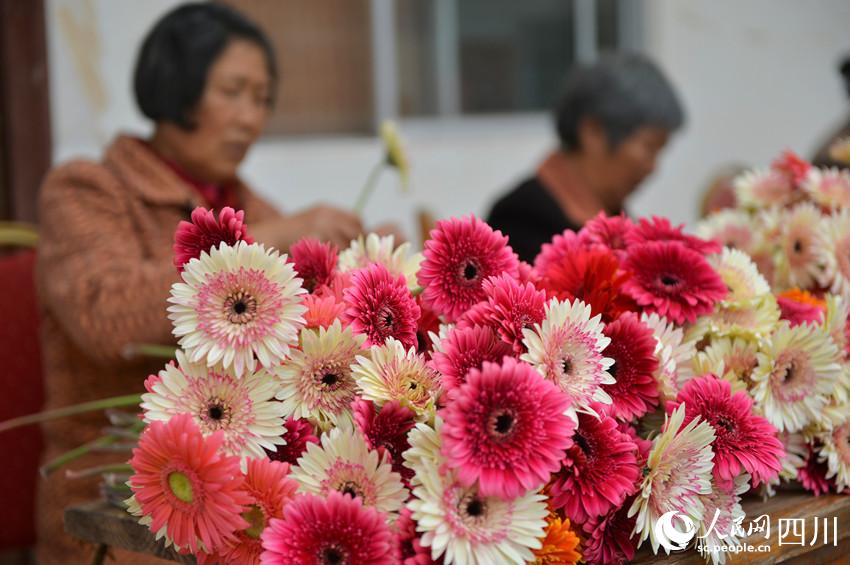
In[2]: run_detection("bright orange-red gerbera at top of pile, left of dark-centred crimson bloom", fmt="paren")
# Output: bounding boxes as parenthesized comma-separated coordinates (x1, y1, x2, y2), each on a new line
(540, 248, 637, 323)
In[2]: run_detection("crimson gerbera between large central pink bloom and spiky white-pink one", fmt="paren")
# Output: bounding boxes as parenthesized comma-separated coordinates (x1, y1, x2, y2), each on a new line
(550, 414, 640, 524)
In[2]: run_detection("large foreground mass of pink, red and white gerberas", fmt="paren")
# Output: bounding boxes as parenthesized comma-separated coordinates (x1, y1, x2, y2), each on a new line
(112, 177, 850, 565)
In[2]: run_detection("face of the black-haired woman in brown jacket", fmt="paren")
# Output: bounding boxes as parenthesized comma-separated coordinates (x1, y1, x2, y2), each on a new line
(165, 39, 272, 184)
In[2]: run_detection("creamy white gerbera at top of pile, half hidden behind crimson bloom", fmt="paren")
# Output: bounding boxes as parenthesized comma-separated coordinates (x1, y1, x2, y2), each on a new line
(339, 233, 424, 290)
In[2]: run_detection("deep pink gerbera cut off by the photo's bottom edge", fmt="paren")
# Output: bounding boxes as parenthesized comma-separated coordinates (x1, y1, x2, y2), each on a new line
(262, 492, 395, 565)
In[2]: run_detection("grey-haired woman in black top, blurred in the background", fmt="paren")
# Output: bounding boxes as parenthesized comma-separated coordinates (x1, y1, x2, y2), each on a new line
(487, 54, 684, 261)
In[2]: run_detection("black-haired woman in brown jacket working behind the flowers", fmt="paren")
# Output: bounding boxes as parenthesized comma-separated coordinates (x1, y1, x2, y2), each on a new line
(38, 3, 374, 565)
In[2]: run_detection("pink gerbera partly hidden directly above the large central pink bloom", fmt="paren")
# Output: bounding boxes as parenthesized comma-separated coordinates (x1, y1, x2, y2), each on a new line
(431, 326, 513, 394)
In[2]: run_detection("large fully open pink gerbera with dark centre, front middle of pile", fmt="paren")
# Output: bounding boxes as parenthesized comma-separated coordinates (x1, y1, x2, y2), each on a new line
(441, 358, 575, 499)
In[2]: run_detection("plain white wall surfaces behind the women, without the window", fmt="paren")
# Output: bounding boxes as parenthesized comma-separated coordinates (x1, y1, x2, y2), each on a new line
(48, 0, 850, 246)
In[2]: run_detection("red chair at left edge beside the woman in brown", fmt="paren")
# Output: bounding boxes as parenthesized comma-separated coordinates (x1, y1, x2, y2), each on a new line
(0, 224, 44, 553)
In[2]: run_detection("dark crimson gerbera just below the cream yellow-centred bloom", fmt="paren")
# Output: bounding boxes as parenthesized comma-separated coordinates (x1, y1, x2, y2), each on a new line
(351, 399, 416, 484)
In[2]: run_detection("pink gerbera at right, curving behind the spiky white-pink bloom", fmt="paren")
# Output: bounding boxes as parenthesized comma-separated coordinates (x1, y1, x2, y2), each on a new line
(667, 375, 785, 486)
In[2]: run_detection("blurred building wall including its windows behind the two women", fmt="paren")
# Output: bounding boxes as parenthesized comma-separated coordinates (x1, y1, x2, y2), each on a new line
(46, 0, 850, 240)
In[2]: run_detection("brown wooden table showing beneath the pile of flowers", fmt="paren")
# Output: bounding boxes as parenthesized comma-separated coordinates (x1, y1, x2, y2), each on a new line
(65, 491, 850, 565)
